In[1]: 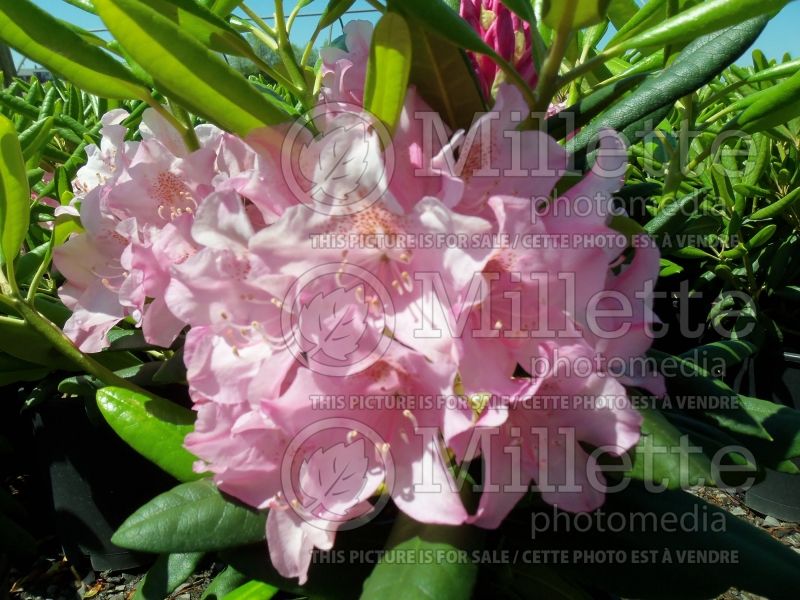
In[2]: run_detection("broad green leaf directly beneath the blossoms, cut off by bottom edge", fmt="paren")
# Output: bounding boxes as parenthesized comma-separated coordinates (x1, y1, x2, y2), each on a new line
(361, 513, 478, 600)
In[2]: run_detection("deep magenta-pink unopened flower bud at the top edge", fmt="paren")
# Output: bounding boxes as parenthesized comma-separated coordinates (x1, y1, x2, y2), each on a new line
(460, 0, 537, 98)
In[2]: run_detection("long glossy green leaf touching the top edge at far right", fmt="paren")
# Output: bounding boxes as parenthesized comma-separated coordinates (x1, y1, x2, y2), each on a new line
(619, 0, 788, 50)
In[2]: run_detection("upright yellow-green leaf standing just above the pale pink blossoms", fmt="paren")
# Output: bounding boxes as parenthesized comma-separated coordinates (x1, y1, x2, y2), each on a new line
(364, 12, 411, 136)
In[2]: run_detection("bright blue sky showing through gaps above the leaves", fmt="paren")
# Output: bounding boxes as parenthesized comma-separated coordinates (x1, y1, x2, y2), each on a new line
(12, 0, 800, 71)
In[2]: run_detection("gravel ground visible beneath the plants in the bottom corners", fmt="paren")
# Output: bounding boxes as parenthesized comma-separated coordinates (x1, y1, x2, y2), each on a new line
(10, 488, 800, 600)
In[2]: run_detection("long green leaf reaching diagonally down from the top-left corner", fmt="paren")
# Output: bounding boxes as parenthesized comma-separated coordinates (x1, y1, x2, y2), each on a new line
(0, 0, 150, 99)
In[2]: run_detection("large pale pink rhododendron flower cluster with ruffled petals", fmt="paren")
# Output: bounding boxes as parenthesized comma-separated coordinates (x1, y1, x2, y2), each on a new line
(56, 19, 661, 582)
